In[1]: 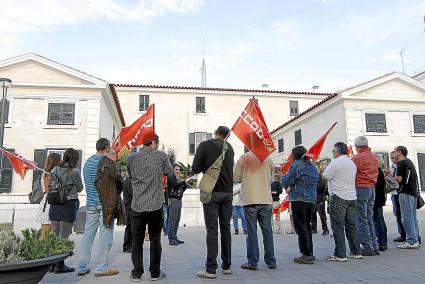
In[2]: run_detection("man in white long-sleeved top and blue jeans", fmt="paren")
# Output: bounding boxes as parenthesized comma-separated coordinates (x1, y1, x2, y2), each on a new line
(323, 142, 362, 262)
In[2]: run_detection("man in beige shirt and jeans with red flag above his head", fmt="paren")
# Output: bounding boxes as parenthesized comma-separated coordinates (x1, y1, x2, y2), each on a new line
(232, 99, 276, 270)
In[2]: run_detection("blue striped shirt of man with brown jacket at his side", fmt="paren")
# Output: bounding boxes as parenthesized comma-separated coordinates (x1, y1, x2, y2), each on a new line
(83, 154, 103, 206)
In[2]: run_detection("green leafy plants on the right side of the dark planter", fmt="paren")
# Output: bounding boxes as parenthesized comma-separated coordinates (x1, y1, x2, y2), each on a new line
(21, 229, 74, 260)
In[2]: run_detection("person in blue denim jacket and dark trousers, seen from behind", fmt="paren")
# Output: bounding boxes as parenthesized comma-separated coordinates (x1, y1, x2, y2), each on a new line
(281, 146, 319, 264)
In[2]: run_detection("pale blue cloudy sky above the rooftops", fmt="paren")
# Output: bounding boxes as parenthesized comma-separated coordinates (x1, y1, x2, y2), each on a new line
(0, 0, 425, 92)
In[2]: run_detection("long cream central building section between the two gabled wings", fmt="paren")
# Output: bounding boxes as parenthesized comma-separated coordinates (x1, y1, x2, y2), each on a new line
(111, 84, 332, 164)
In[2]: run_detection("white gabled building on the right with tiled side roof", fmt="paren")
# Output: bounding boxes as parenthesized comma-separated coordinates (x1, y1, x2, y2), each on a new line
(272, 72, 425, 190)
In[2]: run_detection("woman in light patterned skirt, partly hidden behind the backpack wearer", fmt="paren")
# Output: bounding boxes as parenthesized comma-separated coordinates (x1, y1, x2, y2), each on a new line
(35, 153, 61, 236)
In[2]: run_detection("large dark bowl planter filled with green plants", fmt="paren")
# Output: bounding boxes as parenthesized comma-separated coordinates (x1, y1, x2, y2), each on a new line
(0, 229, 74, 284)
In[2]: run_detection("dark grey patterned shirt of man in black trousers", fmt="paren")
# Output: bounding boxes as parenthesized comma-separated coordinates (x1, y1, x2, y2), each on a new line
(127, 147, 173, 212)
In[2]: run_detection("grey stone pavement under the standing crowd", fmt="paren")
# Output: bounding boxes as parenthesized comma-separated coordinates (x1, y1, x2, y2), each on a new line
(41, 207, 425, 284)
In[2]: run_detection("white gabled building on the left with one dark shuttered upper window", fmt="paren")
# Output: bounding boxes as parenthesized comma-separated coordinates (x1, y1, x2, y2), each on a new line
(0, 54, 124, 203)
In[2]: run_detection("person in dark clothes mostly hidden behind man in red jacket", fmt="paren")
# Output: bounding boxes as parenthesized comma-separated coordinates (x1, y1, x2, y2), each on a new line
(373, 154, 388, 251)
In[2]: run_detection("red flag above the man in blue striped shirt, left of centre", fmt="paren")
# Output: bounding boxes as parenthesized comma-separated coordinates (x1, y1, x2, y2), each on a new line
(112, 105, 155, 159)
